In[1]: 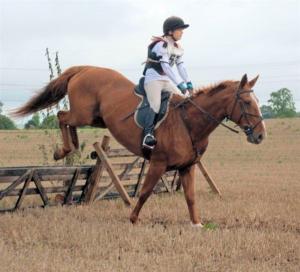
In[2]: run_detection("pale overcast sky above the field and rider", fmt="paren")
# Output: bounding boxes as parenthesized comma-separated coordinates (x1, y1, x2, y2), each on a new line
(0, 0, 300, 125)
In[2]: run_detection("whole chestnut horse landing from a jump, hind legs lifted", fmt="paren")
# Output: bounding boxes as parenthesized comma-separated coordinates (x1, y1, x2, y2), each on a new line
(14, 66, 266, 226)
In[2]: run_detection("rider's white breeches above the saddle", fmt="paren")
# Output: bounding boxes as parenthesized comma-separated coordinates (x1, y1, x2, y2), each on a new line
(144, 80, 184, 113)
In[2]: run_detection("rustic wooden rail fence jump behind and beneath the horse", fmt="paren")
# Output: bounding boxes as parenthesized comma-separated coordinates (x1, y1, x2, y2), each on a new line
(0, 136, 220, 212)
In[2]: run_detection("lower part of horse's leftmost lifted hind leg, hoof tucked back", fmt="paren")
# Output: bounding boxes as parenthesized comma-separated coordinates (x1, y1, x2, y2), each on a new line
(53, 111, 78, 160)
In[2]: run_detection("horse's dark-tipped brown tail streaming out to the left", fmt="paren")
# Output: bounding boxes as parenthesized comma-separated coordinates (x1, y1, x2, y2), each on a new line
(11, 66, 86, 117)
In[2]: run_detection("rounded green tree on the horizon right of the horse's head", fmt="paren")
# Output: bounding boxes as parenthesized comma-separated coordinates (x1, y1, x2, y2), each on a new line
(268, 88, 297, 117)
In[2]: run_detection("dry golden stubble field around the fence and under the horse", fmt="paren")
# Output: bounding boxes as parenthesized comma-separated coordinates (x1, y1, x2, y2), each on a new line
(0, 119, 300, 272)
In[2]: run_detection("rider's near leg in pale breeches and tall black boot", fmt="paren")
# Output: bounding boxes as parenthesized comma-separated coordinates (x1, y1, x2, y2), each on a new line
(143, 80, 163, 149)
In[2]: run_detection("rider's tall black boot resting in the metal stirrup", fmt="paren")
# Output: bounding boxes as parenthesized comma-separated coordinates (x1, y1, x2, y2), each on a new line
(142, 108, 157, 149)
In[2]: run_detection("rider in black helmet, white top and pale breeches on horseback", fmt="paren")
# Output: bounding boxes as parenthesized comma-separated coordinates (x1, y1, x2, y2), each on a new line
(143, 16, 193, 149)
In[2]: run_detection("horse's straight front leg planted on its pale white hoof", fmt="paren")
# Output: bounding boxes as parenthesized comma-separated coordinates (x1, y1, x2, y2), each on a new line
(179, 165, 202, 227)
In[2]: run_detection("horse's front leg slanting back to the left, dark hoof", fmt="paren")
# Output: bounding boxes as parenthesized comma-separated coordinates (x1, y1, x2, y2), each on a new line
(130, 161, 166, 223)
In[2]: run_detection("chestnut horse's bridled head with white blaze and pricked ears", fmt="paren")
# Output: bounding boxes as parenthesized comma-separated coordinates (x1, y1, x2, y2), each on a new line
(226, 74, 266, 144)
